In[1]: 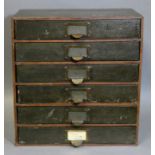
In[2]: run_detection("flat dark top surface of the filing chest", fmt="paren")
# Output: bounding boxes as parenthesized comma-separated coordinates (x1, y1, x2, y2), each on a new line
(14, 9, 142, 19)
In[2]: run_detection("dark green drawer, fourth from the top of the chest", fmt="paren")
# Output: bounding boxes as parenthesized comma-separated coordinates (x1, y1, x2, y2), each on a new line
(17, 85, 138, 104)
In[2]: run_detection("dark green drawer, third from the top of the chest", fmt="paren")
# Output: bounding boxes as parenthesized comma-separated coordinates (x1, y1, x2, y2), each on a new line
(16, 64, 139, 84)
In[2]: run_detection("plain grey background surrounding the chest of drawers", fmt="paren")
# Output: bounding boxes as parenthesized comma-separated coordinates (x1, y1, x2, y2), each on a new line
(4, 0, 151, 155)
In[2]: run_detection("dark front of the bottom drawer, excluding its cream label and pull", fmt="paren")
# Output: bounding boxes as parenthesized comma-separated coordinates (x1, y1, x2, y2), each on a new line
(18, 127, 136, 144)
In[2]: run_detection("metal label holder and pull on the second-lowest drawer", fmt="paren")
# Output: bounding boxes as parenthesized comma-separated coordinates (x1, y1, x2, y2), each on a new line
(68, 112, 87, 126)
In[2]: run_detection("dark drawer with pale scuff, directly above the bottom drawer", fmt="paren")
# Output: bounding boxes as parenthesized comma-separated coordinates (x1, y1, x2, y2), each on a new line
(17, 107, 137, 126)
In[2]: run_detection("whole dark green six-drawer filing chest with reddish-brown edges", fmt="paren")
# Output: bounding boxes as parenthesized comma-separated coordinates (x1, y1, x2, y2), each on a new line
(12, 9, 143, 146)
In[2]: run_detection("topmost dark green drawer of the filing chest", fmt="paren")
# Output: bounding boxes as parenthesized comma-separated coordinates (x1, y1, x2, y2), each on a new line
(15, 19, 141, 40)
